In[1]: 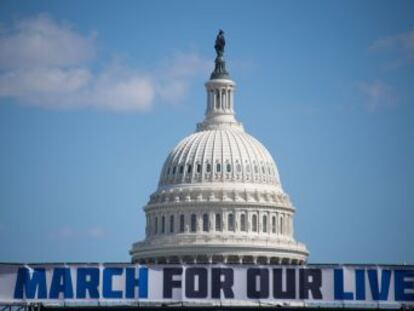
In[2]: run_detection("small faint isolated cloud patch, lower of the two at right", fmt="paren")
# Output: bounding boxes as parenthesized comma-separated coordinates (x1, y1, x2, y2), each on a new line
(358, 81, 397, 111)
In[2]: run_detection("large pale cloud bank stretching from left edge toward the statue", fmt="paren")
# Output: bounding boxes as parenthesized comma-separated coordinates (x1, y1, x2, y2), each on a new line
(0, 15, 209, 111)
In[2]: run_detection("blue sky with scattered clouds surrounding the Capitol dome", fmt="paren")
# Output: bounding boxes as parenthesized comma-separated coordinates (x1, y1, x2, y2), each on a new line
(0, 1, 414, 264)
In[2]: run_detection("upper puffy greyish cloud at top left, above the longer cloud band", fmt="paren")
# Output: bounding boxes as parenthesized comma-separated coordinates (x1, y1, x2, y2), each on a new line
(0, 15, 96, 69)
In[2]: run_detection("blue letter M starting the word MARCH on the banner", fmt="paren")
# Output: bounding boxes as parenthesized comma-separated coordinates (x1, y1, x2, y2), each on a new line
(14, 268, 47, 299)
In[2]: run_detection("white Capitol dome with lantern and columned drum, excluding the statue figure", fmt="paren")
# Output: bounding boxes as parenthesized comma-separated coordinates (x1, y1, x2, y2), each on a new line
(130, 32, 308, 264)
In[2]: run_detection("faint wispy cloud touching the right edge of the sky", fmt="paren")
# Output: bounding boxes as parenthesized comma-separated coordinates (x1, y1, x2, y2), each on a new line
(369, 28, 414, 67)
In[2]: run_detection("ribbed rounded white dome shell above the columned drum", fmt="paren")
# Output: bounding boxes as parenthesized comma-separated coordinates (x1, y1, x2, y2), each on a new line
(159, 128, 280, 189)
